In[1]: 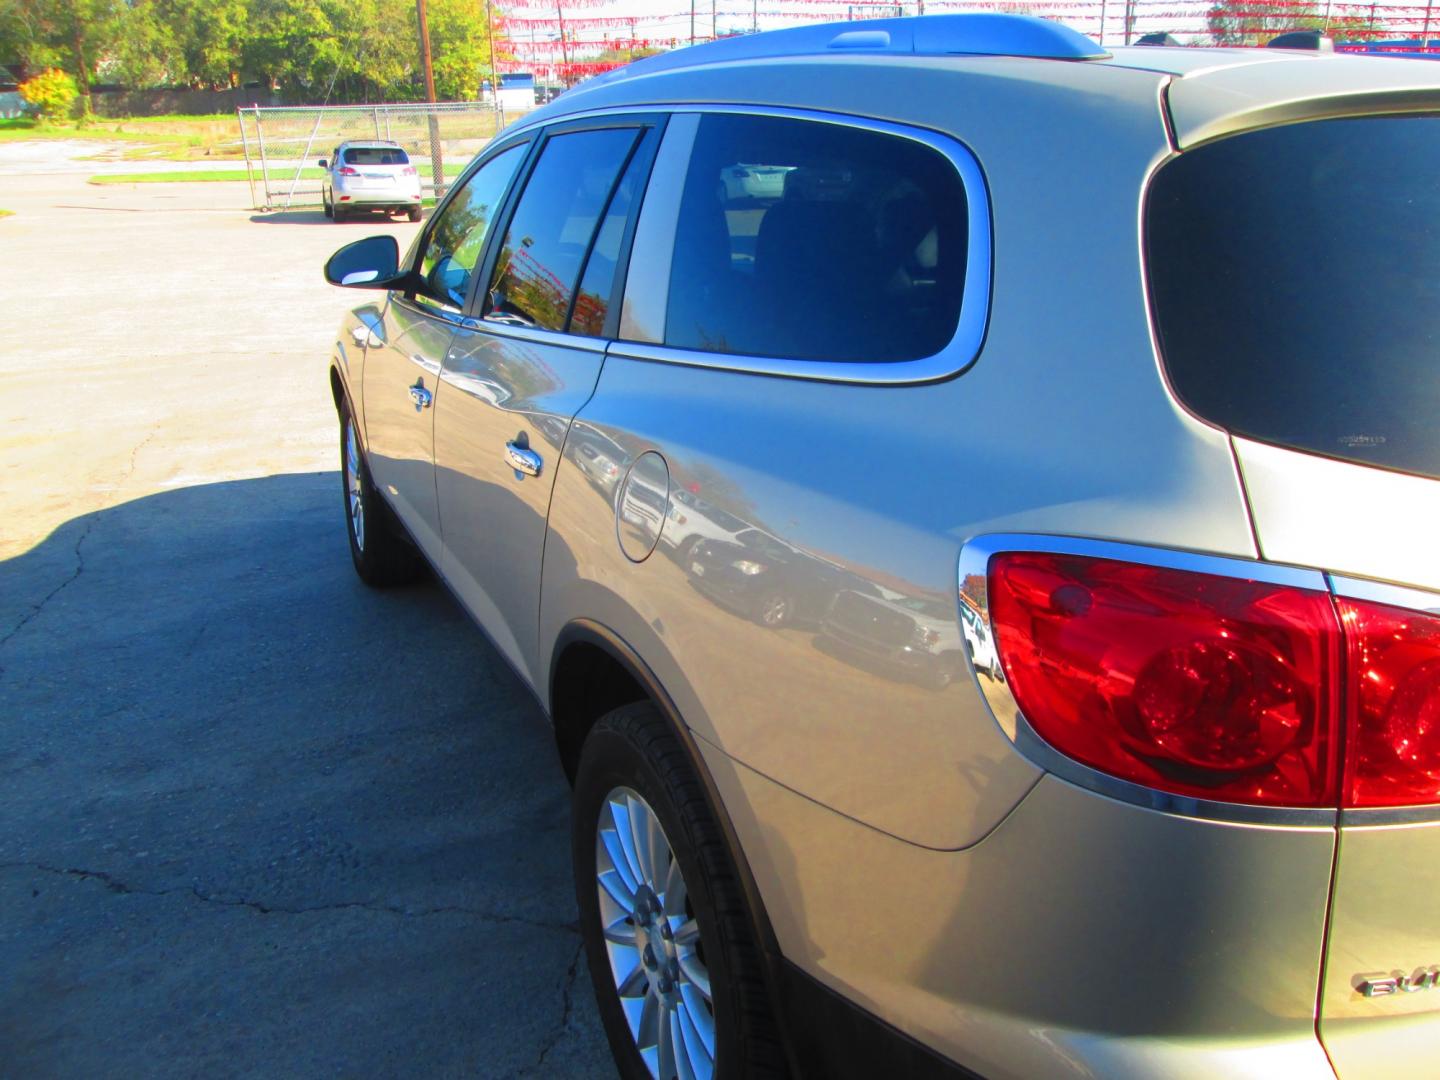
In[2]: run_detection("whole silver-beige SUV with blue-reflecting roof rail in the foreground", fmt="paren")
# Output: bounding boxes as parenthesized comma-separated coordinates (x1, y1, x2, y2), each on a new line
(327, 16, 1440, 1080)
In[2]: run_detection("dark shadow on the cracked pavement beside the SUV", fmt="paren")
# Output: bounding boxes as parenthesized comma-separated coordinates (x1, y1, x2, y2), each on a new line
(0, 472, 613, 1076)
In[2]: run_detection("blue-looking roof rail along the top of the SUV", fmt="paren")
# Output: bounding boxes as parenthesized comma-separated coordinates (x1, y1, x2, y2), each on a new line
(578, 13, 1110, 86)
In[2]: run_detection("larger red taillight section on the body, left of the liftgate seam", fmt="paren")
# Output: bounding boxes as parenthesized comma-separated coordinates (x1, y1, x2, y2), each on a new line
(989, 553, 1339, 806)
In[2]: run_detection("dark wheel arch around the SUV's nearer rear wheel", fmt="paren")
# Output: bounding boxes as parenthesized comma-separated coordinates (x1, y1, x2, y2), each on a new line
(549, 619, 802, 1076)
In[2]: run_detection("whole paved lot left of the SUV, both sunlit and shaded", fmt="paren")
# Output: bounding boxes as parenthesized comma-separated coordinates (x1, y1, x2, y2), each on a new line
(0, 144, 613, 1077)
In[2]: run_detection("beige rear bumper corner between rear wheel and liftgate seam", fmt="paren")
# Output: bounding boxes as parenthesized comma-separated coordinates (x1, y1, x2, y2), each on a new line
(701, 743, 1335, 1080)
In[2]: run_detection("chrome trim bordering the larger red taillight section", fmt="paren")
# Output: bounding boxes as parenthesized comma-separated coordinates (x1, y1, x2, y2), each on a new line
(958, 533, 1336, 828)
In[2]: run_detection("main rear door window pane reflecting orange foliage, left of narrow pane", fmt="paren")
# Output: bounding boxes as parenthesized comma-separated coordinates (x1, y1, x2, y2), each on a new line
(485, 128, 639, 330)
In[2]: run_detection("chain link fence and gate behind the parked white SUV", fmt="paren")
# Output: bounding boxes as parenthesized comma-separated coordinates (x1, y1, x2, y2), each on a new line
(244, 101, 505, 210)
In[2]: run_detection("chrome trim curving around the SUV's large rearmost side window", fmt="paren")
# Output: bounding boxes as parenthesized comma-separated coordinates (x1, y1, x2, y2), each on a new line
(584, 104, 994, 384)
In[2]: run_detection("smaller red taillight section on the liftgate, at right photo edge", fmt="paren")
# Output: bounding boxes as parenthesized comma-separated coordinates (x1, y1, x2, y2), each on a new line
(1336, 598, 1440, 806)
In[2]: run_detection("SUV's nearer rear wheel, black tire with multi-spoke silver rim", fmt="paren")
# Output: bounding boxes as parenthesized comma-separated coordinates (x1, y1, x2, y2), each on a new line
(572, 701, 788, 1080)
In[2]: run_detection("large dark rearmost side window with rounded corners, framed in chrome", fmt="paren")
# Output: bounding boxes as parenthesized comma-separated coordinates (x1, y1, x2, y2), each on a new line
(665, 115, 968, 361)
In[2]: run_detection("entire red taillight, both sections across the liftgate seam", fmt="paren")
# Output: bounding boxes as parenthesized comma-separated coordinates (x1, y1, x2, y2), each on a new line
(988, 552, 1440, 808)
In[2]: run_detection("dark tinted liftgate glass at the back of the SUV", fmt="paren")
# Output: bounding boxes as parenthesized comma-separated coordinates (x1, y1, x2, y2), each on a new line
(1145, 117, 1440, 478)
